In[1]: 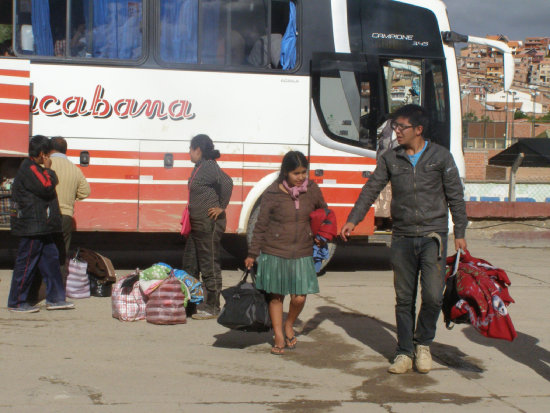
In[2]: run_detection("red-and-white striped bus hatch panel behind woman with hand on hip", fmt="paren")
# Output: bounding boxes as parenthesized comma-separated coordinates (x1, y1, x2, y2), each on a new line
(138, 140, 243, 232)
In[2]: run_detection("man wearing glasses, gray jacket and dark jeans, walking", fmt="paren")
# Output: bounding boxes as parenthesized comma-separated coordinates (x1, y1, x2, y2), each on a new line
(340, 105, 468, 374)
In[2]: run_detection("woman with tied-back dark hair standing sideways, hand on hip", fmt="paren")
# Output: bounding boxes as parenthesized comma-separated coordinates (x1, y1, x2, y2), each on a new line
(183, 135, 233, 320)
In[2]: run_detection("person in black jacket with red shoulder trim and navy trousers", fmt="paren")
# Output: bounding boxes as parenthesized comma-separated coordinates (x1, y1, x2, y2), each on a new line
(8, 135, 74, 313)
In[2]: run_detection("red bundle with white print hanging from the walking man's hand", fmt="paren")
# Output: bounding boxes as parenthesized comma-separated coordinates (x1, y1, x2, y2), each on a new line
(442, 250, 517, 341)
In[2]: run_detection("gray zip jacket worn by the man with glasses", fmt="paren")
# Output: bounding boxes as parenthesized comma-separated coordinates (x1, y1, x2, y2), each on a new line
(348, 141, 468, 238)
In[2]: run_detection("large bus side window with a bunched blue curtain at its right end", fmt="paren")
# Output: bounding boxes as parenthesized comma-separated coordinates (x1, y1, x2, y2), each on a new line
(158, 0, 296, 69)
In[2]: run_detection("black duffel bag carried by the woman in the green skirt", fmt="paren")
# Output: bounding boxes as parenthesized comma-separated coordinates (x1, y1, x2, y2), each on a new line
(218, 271, 271, 333)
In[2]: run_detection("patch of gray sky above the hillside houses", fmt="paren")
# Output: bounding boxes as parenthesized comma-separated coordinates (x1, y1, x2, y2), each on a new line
(443, 0, 550, 40)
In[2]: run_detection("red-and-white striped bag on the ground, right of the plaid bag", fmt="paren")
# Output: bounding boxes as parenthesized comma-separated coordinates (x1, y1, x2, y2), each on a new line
(145, 276, 187, 324)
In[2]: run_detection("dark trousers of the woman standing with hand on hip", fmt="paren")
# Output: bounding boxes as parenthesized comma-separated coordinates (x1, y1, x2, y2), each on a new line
(183, 214, 226, 309)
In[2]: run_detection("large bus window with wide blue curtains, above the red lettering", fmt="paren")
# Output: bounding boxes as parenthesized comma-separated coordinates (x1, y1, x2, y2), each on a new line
(15, 0, 143, 60)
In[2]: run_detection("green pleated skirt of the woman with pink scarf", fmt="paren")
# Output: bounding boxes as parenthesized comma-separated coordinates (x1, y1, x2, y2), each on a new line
(256, 254, 319, 295)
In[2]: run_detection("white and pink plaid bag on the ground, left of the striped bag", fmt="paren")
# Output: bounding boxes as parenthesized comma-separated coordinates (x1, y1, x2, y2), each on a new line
(111, 273, 146, 321)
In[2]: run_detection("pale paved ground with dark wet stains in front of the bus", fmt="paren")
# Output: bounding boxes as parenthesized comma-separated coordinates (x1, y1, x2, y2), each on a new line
(0, 235, 550, 413)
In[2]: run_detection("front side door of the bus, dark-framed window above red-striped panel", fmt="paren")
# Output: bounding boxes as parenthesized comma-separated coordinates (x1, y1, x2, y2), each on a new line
(311, 53, 379, 235)
